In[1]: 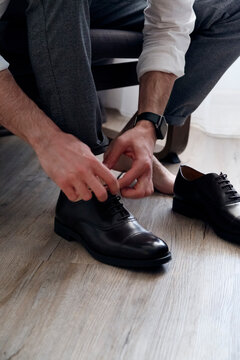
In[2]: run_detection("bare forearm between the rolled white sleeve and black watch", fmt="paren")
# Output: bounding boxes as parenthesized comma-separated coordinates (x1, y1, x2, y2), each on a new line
(138, 71, 177, 114)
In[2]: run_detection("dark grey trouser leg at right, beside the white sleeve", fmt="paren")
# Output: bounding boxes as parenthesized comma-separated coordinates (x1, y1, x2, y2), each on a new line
(166, 0, 240, 125)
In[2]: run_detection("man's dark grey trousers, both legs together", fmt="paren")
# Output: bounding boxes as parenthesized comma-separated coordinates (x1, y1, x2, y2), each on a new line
(26, 0, 240, 154)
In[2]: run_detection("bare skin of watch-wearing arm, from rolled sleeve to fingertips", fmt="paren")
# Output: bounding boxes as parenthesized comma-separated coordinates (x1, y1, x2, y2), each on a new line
(104, 71, 176, 198)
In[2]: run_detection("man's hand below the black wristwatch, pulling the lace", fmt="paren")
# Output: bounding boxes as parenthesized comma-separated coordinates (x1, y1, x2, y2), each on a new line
(104, 120, 156, 198)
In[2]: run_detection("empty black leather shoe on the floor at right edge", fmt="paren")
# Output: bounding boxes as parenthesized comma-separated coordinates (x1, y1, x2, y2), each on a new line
(173, 166, 240, 243)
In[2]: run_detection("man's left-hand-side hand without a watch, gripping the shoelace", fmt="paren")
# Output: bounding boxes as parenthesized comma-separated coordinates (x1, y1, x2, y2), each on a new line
(35, 131, 119, 201)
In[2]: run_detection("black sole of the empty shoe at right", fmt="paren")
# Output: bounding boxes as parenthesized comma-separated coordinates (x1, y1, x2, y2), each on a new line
(172, 198, 240, 243)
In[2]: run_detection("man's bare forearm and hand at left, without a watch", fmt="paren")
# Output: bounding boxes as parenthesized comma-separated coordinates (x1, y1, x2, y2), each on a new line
(0, 70, 119, 201)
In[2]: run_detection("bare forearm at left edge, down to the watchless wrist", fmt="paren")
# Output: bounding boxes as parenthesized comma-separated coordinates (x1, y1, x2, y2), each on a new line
(0, 70, 60, 149)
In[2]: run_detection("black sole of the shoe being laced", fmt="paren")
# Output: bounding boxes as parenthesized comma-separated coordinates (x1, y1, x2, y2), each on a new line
(54, 219, 172, 268)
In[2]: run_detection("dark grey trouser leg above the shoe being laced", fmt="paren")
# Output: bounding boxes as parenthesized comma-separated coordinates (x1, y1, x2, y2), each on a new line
(26, 0, 107, 154)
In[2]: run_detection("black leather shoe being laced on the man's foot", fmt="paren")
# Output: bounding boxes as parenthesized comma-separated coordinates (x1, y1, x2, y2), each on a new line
(55, 192, 171, 268)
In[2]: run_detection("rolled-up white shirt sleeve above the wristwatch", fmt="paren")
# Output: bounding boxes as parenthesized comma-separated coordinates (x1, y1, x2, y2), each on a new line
(137, 0, 195, 79)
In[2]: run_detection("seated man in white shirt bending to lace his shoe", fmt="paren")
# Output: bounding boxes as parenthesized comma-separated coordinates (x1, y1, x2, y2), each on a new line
(0, 0, 240, 267)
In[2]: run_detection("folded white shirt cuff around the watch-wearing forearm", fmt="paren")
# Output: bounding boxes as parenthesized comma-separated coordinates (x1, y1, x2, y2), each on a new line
(137, 46, 185, 80)
